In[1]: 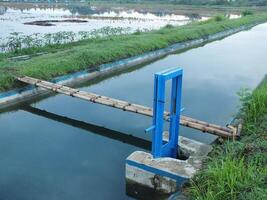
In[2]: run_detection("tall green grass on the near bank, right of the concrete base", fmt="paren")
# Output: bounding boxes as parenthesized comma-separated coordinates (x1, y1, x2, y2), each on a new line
(189, 77, 267, 200)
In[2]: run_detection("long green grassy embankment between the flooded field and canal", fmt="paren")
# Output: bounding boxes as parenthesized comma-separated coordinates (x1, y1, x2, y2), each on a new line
(0, 13, 267, 91)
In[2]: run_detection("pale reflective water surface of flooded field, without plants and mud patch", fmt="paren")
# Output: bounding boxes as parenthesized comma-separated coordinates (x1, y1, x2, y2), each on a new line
(0, 4, 207, 39)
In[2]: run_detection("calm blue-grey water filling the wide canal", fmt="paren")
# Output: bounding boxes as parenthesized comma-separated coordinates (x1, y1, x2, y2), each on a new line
(0, 24, 267, 200)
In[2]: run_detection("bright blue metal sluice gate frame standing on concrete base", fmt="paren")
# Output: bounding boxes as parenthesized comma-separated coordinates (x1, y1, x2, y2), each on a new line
(146, 68, 183, 158)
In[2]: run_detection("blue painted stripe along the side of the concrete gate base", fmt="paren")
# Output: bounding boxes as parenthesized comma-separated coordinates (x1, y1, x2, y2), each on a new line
(126, 160, 188, 185)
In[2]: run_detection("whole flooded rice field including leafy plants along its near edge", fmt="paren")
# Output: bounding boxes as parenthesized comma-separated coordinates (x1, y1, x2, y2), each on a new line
(0, 4, 213, 52)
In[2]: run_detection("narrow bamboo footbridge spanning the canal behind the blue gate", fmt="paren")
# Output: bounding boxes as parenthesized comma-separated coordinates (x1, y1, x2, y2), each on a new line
(17, 76, 238, 138)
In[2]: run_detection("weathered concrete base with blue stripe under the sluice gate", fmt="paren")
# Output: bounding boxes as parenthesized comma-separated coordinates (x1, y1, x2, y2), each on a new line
(126, 133, 212, 199)
